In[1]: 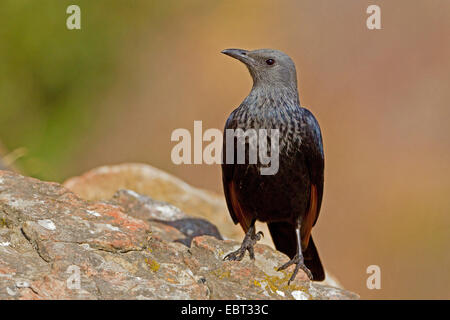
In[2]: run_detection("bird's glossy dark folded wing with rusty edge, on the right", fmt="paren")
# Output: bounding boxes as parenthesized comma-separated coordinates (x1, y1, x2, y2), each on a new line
(300, 109, 324, 249)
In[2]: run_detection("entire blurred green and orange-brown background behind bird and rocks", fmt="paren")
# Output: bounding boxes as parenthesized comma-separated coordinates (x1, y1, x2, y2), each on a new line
(0, 0, 450, 299)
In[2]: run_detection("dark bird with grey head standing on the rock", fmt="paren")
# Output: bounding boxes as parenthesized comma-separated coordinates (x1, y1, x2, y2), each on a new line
(221, 49, 325, 285)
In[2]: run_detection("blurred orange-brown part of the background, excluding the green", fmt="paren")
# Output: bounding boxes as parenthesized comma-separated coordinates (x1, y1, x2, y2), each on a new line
(0, 0, 450, 299)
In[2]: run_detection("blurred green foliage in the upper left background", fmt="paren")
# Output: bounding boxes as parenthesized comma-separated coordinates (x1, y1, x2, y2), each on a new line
(0, 0, 175, 180)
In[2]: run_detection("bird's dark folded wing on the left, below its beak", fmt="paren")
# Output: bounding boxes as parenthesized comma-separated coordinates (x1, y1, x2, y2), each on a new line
(222, 112, 252, 232)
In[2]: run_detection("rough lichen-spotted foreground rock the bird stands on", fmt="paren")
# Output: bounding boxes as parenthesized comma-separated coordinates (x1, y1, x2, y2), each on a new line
(0, 171, 358, 299)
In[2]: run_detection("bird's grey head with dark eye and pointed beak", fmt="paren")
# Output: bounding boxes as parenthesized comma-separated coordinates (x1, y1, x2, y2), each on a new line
(222, 49, 297, 90)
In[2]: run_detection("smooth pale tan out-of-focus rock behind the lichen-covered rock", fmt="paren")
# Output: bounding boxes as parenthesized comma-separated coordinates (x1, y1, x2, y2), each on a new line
(64, 163, 262, 245)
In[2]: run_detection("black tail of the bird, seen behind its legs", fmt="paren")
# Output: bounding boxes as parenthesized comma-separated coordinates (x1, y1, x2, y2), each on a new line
(268, 222, 325, 281)
